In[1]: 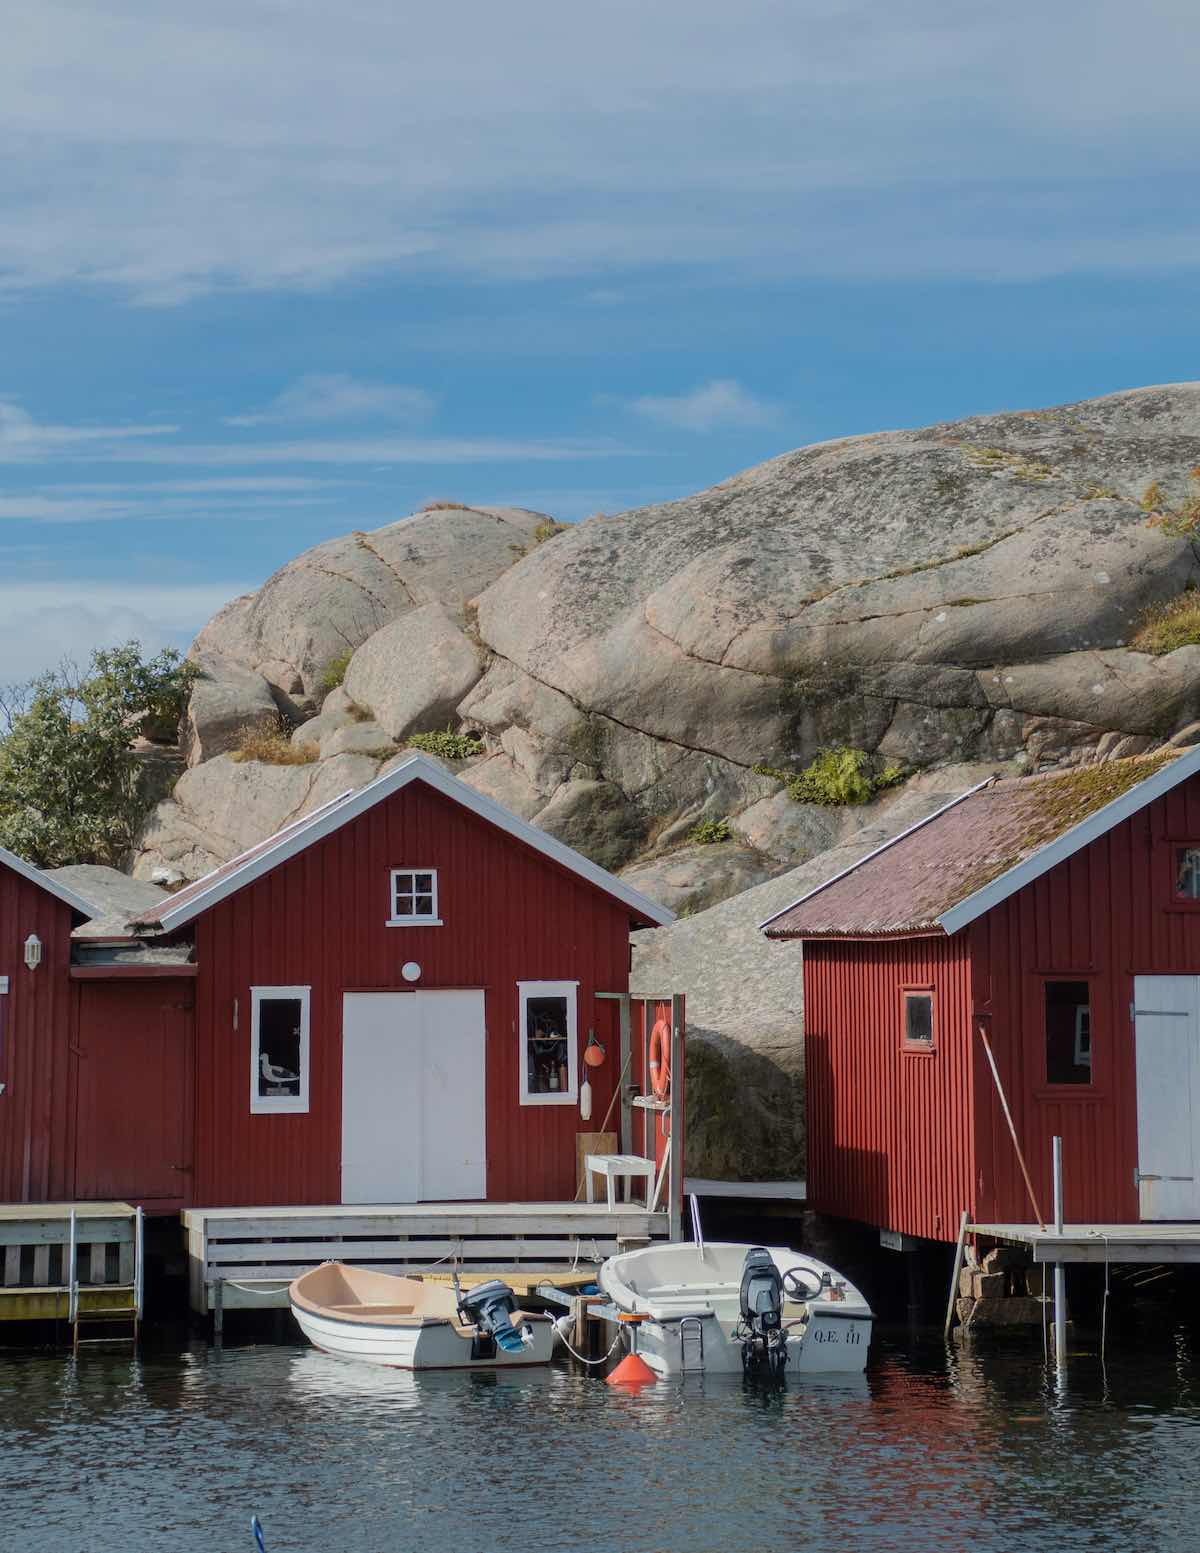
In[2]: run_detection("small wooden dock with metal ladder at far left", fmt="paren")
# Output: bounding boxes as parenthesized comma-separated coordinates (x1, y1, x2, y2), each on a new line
(0, 1202, 141, 1323)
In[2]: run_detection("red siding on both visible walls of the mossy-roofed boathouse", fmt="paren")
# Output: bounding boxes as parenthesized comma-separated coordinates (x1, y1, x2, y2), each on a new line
(804, 777, 1200, 1241)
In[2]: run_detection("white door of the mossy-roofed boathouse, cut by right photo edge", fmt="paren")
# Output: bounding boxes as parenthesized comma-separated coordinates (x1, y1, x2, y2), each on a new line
(1133, 975, 1200, 1221)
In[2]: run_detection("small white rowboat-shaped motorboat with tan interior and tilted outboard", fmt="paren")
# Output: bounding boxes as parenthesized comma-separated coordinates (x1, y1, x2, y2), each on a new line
(289, 1263, 554, 1370)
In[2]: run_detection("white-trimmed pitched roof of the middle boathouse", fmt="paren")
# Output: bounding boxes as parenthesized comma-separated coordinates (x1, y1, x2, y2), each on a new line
(129, 752, 675, 932)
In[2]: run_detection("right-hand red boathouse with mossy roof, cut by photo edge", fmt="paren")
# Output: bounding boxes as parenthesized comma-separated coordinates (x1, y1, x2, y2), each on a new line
(762, 749, 1200, 1241)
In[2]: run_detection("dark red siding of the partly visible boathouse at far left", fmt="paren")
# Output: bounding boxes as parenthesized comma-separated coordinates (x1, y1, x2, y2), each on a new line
(0, 860, 78, 1202)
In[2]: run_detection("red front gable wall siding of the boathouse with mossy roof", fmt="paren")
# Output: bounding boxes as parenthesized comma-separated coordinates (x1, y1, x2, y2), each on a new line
(967, 777, 1200, 1224)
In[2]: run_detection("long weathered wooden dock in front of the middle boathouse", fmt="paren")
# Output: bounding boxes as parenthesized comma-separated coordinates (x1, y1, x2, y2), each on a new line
(182, 1202, 669, 1318)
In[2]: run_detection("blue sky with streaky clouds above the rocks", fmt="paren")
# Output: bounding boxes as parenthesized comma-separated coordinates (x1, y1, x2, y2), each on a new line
(0, 0, 1200, 683)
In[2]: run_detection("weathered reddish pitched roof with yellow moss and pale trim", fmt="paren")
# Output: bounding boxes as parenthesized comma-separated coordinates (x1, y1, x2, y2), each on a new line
(759, 745, 1200, 938)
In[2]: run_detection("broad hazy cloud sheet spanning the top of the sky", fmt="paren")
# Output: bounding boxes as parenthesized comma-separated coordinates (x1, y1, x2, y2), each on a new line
(0, 0, 1200, 304)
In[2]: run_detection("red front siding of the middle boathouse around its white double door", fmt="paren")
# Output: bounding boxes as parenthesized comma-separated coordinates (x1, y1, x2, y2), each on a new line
(192, 781, 629, 1205)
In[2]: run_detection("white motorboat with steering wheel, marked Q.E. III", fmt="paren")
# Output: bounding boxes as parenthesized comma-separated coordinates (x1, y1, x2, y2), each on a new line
(599, 1241, 874, 1378)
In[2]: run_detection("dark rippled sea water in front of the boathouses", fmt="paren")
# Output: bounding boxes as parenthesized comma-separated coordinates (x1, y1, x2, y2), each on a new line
(0, 1320, 1200, 1553)
